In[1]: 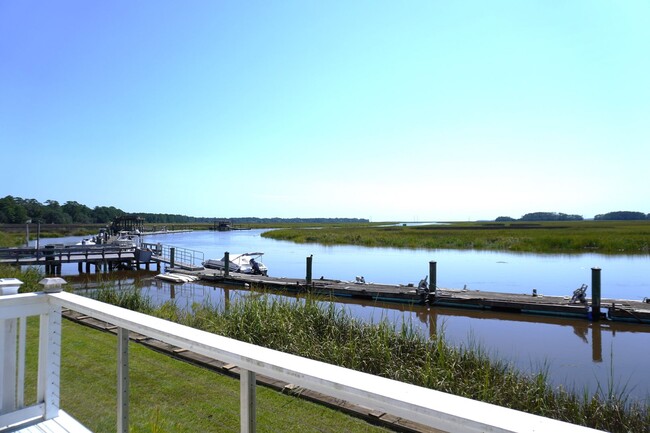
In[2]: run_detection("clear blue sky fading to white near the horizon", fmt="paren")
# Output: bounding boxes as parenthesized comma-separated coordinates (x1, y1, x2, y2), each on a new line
(0, 0, 650, 221)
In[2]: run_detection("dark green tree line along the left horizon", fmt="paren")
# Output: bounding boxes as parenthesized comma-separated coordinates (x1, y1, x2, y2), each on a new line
(0, 195, 368, 224)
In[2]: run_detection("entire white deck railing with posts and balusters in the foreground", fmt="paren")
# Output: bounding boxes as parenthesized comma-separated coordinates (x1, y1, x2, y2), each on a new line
(0, 292, 595, 433)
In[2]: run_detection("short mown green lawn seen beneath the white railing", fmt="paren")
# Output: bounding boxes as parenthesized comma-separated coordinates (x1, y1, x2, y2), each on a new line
(28, 320, 386, 433)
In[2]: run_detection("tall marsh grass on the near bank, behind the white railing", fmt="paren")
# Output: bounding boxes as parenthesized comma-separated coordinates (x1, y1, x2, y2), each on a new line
(90, 286, 650, 432)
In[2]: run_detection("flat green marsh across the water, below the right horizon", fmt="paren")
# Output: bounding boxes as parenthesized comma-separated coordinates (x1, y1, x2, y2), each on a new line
(262, 221, 650, 255)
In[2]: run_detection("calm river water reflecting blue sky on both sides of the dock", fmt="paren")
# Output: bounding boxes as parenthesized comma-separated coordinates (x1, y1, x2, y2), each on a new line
(53, 230, 650, 400)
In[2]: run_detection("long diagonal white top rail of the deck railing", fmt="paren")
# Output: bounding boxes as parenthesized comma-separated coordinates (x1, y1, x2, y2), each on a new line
(48, 292, 595, 433)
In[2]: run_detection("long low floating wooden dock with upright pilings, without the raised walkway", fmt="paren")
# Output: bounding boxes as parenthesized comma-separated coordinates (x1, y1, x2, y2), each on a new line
(166, 269, 650, 324)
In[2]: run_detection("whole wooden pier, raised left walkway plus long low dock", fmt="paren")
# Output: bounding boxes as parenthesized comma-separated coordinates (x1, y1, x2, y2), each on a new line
(5, 242, 650, 324)
